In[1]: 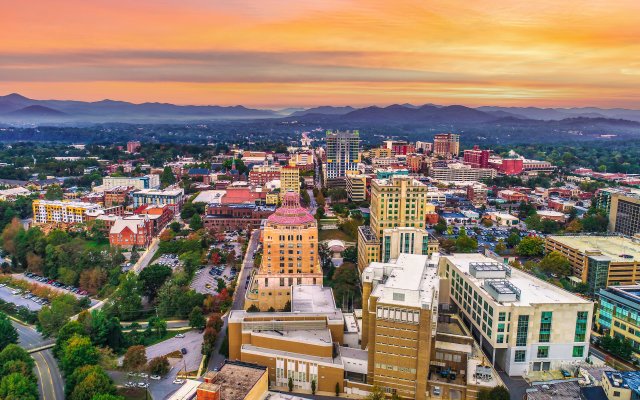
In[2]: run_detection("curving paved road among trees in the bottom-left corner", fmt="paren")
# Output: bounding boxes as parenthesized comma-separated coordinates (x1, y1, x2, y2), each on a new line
(11, 321, 64, 400)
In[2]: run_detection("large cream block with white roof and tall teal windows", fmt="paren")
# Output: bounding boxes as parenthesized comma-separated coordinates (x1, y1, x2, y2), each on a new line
(439, 254, 593, 376)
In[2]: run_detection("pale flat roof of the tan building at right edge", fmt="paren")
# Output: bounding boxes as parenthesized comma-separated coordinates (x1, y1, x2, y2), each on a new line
(548, 235, 640, 262)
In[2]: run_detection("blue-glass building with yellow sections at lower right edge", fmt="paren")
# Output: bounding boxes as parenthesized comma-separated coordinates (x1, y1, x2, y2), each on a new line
(596, 285, 640, 359)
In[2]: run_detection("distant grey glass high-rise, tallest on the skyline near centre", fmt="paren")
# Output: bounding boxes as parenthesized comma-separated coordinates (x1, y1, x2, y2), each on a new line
(325, 131, 360, 179)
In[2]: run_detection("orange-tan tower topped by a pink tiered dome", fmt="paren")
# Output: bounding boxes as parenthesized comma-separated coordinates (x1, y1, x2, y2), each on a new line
(245, 192, 322, 310)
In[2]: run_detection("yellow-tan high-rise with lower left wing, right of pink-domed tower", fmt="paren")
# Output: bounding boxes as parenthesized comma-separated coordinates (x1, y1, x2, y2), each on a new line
(358, 176, 428, 272)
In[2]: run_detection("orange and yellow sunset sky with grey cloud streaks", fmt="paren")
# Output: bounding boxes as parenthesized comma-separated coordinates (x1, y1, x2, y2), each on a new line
(0, 0, 640, 109)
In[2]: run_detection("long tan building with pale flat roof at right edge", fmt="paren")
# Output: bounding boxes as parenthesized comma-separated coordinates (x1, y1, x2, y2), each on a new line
(545, 235, 640, 295)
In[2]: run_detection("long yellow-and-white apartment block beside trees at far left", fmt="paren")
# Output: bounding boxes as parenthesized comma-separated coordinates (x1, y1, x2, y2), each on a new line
(32, 200, 102, 224)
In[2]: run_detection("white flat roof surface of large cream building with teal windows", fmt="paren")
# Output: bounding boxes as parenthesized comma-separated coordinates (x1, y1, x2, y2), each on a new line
(442, 253, 589, 306)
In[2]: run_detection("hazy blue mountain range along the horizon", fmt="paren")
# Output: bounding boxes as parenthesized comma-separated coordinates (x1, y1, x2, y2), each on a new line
(0, 93, 640, 127)
